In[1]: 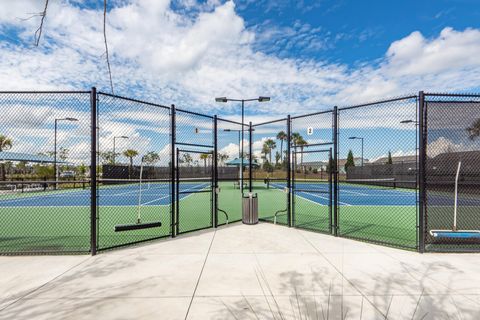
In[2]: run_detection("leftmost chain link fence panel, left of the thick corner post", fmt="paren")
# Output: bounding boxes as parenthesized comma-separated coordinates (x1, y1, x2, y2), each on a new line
(0, 92, 91, 254)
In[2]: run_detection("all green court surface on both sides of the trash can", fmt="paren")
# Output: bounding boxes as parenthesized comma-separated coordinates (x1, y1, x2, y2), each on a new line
(0, 181, 417, 253)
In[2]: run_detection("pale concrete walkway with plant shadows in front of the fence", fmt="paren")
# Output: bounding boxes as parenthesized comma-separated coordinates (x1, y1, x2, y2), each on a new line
(0, 224, 480, 320)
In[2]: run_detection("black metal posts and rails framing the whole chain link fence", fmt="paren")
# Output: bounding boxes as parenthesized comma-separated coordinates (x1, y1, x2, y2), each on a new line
(0, 87, 480, 255)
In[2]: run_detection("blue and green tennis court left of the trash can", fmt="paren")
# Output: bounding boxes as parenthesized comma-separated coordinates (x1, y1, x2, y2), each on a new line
(0, 180, 241, 252)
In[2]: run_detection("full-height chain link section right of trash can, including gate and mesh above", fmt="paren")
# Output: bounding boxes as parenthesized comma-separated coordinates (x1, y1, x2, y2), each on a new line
(291, 111, 334, 233)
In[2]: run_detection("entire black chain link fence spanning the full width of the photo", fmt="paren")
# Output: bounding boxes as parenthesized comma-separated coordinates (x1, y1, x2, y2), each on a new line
(0, 89, 480, 254)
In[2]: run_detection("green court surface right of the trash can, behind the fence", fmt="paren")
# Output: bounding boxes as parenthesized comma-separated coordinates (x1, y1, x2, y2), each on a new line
(254, 183, 417, 248)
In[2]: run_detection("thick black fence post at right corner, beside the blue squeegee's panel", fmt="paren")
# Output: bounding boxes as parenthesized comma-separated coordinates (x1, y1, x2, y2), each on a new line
(418, 91, 427, 253)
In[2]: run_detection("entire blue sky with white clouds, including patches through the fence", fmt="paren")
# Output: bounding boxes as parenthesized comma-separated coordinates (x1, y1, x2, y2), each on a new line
(0, 0, 480, 164)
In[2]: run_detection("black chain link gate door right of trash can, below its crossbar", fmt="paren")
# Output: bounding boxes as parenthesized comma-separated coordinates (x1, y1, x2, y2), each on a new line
(292, 143, 334, 233)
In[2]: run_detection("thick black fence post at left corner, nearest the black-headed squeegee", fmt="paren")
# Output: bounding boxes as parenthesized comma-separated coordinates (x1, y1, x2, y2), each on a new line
(90, 87, 97, 256)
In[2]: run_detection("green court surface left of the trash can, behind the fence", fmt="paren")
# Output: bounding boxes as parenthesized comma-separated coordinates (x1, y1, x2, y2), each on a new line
(0, 182, 241, 253)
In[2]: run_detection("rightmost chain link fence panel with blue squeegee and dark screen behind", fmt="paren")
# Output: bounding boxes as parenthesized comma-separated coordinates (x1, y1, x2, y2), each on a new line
(423, 94, 480, 252)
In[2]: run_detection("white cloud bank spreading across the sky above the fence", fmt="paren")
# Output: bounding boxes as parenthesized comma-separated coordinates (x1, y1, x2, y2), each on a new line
(0, 0, 480, 123)
